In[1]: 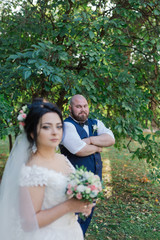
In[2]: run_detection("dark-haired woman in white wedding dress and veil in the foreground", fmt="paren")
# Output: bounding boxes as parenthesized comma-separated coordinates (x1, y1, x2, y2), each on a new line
(0, 102, 93, 240)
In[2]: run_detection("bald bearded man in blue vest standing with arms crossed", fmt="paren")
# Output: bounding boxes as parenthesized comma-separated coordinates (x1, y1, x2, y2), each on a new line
(60, 94, 115, 236)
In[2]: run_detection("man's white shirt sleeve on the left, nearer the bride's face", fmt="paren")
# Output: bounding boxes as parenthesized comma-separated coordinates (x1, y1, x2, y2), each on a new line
(61, 122, 86, 154)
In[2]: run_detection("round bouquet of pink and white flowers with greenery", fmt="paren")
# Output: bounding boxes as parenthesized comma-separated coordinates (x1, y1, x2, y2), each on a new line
(66, 166, 102, 202)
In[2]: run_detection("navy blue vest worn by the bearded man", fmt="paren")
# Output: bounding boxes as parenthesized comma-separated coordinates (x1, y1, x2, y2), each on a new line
(60, 117, 102, 179)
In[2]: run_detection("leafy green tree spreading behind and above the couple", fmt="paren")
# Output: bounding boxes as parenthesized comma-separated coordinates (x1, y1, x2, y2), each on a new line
(0, 0, 160, 180)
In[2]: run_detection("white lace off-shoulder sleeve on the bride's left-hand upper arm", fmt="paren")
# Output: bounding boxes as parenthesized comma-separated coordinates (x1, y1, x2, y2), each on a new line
(19, 166, 48, 187)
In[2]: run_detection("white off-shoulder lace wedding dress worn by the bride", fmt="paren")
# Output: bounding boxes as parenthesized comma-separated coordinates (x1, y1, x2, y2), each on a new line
(15, 163, 84, 240)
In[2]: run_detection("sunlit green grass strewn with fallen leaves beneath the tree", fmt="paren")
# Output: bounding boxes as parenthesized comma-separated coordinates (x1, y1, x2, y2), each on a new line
(0, 138, 160, 240)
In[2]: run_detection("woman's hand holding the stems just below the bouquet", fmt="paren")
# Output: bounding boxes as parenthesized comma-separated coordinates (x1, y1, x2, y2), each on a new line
(68, 198, 96, 216)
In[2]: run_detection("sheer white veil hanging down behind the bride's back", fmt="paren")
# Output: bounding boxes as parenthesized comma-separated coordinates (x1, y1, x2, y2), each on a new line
(0, 132, 38, 240)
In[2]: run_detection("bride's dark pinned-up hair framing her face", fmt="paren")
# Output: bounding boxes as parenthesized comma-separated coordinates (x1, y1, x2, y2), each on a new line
(24, 101, 63, 145)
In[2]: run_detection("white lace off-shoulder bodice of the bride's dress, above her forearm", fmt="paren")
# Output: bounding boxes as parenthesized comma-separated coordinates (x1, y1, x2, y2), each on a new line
(20, 165, 67, 209)
